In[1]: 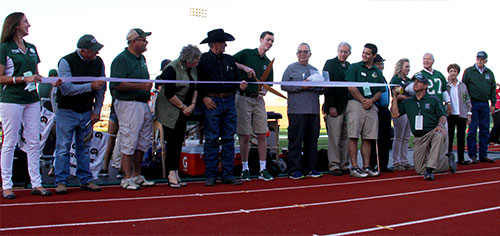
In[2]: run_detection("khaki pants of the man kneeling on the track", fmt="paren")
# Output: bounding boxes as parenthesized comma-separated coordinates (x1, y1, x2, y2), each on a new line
(413, 131, 450, 174)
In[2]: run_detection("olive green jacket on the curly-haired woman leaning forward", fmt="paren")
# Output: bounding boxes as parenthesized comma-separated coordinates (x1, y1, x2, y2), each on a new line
(155, 59, 198, 129)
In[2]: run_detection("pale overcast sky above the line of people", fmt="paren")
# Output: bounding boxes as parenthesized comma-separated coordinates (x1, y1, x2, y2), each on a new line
(0, 0, 500, 104)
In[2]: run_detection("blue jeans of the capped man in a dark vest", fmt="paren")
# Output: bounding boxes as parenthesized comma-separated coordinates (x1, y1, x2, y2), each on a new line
(54, 108, 92, 184)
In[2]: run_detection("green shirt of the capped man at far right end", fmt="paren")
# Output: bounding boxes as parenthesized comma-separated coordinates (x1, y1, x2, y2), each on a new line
(462, 65, 497, 105)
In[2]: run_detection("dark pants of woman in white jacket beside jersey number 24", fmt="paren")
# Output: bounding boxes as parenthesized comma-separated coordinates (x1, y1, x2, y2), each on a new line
(447, 115, 467, 162)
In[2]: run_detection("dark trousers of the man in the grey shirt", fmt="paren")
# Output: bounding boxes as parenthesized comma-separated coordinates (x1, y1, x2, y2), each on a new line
(287, 114, 320, 174)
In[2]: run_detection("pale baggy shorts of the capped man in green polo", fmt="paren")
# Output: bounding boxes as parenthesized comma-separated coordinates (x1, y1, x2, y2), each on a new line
(114, 99, 153, 155)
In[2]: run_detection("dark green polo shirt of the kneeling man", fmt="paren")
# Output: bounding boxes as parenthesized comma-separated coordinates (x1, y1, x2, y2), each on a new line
(398, 93, 446, 137)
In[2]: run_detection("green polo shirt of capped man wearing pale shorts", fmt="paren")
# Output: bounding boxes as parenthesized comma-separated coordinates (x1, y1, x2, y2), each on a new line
(109, 48, 151, 102)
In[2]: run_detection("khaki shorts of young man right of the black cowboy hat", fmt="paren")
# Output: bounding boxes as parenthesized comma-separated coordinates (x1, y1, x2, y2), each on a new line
(235, 94, 267, 135)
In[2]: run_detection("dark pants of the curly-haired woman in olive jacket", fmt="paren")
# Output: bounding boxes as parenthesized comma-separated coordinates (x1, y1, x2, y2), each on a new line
(163, 112, 187, 171)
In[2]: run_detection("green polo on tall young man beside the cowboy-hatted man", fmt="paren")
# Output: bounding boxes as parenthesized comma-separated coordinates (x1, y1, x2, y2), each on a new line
(233, 48, 273, 93)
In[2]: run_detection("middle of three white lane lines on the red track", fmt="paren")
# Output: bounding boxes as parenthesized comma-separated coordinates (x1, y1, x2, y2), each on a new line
(0, 180, 500, 232)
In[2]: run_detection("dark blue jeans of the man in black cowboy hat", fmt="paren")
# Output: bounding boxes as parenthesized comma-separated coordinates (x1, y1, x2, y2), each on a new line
(202, 96, 236, 180)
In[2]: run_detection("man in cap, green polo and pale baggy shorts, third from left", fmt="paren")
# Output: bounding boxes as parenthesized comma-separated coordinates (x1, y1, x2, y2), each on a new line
(109, 28, 155, 190)
